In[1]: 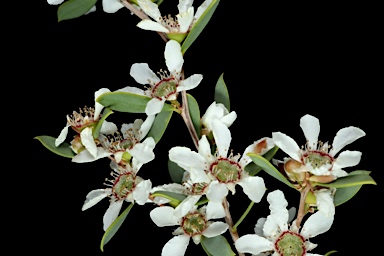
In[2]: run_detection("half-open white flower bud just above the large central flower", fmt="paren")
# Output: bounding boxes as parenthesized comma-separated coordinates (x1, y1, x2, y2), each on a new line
(201, 101, 237, 132)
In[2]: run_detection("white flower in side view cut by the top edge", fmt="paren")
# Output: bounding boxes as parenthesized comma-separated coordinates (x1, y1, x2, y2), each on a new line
(137, 0, 212, 42)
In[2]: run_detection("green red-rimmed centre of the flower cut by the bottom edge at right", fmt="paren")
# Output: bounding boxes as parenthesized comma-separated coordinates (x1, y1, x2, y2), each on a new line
(275, 231, 306, 256)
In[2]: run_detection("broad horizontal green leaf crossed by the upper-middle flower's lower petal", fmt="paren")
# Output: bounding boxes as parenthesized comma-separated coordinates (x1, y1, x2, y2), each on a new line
(96, 91, 175, 113)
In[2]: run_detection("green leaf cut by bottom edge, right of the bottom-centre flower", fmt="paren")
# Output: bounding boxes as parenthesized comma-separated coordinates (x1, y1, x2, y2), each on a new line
(201, 235, 236, 256)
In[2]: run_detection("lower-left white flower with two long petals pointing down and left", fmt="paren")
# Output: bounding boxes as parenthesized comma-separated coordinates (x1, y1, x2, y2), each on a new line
(82, 159, 152, 230)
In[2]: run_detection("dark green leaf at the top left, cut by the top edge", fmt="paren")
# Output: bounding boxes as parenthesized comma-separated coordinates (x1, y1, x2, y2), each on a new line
(57, 0, 97, 22)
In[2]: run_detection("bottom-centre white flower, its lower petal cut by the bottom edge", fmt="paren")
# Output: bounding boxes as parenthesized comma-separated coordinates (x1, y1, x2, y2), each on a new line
(150, 203, 228, 256)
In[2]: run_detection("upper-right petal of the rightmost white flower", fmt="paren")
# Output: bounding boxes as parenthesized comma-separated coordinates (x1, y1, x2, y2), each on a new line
(329, 126, 365, 156)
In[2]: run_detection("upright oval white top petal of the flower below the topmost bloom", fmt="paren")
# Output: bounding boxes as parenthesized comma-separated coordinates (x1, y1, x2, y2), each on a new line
(164, 40, 184, 74)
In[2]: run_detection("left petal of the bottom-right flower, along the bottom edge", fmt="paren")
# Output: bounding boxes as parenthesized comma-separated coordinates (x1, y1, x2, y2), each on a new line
(235, 235, 273, 255)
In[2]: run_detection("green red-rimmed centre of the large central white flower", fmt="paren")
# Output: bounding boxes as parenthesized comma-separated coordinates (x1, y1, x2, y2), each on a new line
(211, 158, 242, 183)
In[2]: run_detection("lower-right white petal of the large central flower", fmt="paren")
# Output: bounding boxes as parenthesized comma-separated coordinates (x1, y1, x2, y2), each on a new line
(238, 176, 267, 203)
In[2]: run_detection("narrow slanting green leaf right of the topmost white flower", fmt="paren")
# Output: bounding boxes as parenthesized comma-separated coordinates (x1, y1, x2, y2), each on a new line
(181, 0, 220, 54)
